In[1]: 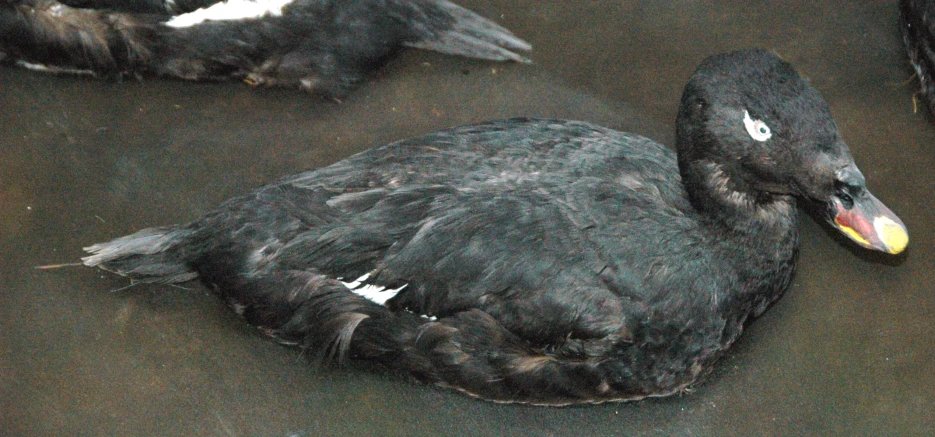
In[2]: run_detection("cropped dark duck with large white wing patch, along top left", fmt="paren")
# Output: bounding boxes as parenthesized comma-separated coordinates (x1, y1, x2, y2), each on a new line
(0, 0, 530, 97)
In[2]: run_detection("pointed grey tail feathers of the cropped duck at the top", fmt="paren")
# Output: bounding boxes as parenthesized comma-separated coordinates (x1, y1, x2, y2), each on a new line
(405, 0, 532, 63)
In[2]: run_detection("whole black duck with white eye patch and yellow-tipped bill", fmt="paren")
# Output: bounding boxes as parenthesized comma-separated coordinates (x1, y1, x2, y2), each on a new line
(84, 50, 908, 405)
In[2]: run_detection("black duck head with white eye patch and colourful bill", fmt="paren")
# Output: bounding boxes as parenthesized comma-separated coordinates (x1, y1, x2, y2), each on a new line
(677, 49, 909, 254)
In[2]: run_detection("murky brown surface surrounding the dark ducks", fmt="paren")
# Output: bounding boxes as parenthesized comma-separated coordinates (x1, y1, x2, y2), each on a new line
(0, 0, 935, 437)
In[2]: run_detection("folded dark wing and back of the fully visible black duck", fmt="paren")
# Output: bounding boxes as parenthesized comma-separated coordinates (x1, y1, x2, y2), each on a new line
(208, 119, 690, 343)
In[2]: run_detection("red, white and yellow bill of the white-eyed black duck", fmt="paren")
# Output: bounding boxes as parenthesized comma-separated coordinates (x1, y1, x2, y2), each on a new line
(829, 190, 909, 255)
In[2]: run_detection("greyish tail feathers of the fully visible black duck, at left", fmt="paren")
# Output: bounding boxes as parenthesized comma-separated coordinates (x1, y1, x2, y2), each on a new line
(81, 226, 198, 283)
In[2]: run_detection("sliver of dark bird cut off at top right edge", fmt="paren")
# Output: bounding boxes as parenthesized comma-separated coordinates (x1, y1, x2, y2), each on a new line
(899, 0, 935, 114)
